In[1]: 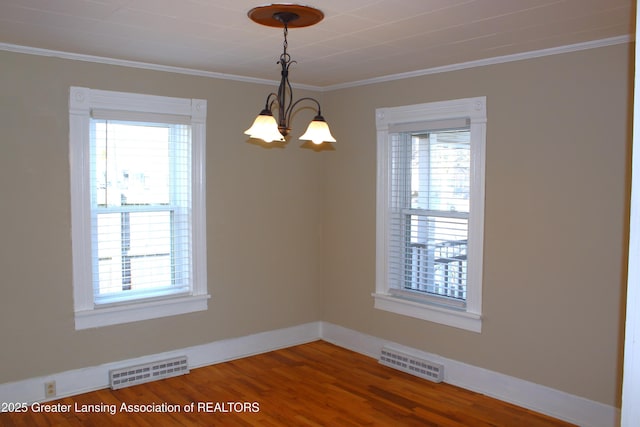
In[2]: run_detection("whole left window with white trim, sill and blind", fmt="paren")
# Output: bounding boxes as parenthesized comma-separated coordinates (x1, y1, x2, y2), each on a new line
(69, 87, 208, 329)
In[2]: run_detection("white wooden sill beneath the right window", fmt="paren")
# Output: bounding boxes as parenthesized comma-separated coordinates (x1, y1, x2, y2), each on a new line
(372, 293, 482, 333)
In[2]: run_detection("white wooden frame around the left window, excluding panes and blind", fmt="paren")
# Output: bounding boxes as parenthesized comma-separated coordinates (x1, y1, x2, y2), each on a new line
(69, 87, 209, 329)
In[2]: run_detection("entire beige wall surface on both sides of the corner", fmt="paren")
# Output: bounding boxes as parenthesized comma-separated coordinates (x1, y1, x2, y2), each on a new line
(0, 41, 630, 406)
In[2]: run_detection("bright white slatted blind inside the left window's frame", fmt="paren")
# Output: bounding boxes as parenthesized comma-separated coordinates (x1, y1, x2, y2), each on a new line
(90, 118, 191, 305)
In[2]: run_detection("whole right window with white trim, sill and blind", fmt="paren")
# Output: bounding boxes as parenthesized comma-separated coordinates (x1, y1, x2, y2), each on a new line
(374, 97, 486, 332)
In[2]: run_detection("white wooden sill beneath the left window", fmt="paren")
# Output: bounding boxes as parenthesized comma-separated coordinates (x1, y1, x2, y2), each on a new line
(75, 295, 209, 330)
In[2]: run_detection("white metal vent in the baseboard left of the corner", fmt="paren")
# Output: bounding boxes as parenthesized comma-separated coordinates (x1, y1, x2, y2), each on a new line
(109, 356, 189, 390)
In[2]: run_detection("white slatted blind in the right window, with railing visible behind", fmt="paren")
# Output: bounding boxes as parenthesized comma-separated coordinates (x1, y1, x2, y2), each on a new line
(388, 128, 471, 306)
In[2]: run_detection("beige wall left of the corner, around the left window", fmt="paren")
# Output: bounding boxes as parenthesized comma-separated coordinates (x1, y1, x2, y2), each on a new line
(0, 52, 322, 383)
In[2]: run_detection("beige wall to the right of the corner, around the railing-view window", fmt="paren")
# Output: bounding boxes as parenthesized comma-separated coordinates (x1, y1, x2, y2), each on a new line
(322, 45, 631, 406)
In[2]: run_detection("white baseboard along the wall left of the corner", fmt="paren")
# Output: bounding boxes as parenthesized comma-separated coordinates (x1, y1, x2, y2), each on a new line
(0, 322, 321, 404)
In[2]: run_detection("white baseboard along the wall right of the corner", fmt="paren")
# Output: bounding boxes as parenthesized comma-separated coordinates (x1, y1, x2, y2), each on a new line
(321, 322, 620, 427)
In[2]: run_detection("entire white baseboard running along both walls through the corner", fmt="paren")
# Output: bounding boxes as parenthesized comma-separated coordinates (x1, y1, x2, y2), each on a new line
(0, 322, 620, 427)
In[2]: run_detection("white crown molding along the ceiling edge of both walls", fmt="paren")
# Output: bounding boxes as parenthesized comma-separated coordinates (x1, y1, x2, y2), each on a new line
(0, 36, 634, 92)
